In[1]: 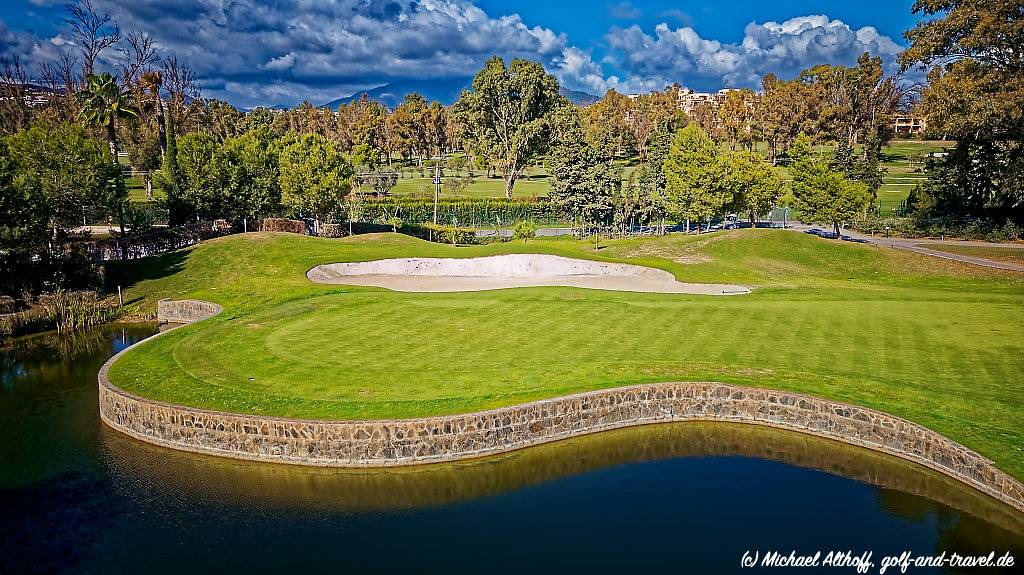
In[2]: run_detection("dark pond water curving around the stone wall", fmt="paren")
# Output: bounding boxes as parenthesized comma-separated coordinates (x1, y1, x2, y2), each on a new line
(0, 326, 1024, 574)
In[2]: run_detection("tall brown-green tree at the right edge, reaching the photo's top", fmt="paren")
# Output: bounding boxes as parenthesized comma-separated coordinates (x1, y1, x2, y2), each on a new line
(900, 0, 1024, 222)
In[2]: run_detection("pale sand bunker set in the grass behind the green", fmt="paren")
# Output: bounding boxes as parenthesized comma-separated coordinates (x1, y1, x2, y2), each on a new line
(306, 254, 751, 296)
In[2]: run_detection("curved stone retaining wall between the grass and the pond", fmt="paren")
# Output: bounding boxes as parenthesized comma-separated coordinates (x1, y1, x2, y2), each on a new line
(99, 302, 1024, 511)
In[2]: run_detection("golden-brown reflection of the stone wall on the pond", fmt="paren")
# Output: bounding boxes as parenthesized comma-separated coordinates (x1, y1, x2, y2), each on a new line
(103, 423, 1024, 534)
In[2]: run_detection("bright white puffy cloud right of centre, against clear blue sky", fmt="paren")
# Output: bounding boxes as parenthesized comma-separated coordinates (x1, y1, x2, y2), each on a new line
(605, 15, 901, 89)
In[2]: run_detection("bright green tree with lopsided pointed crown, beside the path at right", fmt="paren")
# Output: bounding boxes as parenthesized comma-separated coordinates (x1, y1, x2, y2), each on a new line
(790, 134, 871, 238)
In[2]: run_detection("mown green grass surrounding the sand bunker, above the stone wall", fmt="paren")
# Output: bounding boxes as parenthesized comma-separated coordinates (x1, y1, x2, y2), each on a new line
(111, 229, 1024, 477)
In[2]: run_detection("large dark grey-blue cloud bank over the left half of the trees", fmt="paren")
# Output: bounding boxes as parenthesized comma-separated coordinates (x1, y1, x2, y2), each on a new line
(76, 0, 566, 105)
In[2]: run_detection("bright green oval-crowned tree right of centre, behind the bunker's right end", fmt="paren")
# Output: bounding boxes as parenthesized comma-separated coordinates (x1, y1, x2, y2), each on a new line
(665, 124, 730, 232)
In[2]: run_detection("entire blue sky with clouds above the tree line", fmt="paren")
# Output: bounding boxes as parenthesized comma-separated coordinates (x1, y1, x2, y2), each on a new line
(0, 0, 915, 106)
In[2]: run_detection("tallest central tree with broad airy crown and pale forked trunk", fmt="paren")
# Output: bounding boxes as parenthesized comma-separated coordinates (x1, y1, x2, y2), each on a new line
(460, 56, 571, 197)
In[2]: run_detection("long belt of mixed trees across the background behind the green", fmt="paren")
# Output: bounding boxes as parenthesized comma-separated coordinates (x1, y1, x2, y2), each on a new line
(0, 0, 1024, 296)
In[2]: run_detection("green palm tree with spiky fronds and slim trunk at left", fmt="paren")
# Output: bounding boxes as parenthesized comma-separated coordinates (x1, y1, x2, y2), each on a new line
(77, 73, 138, 259)
